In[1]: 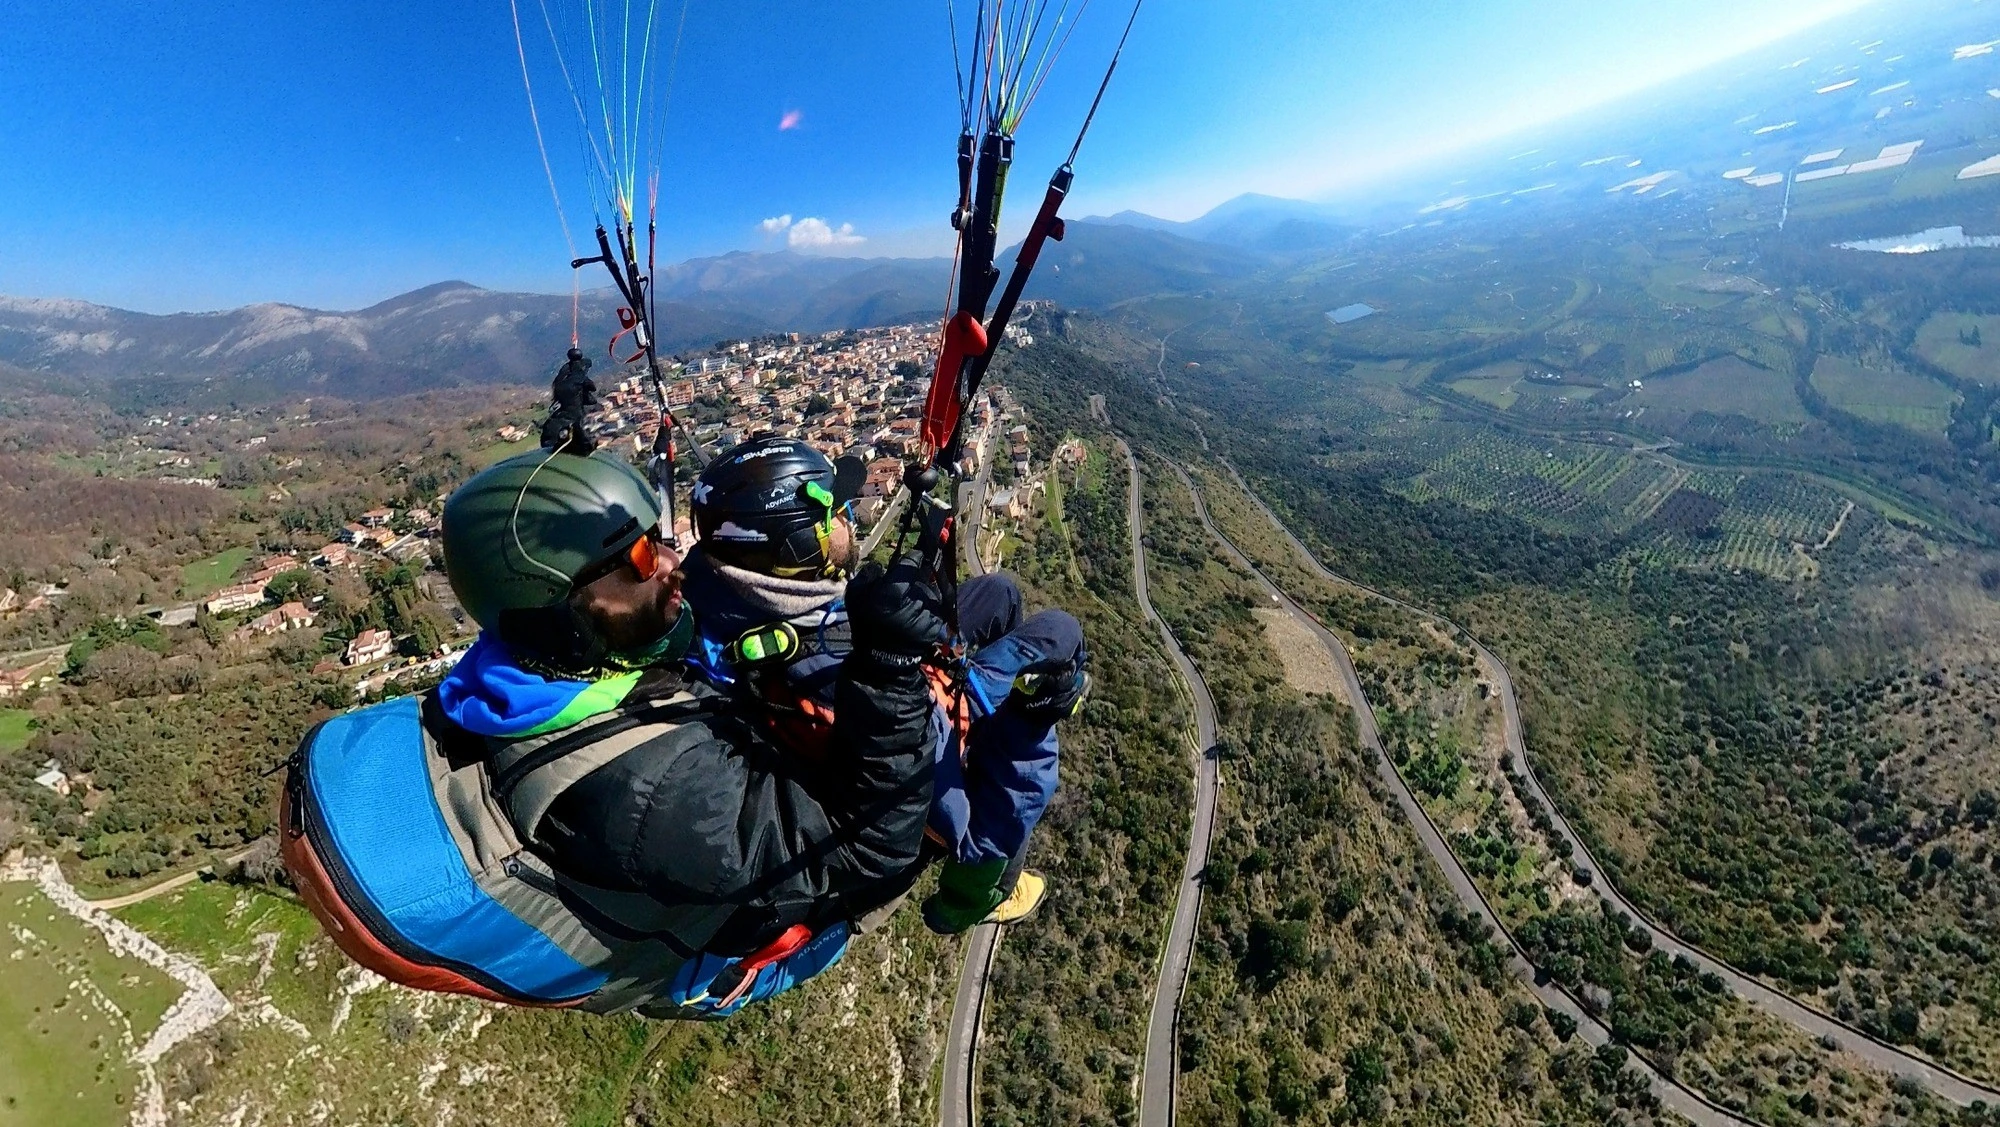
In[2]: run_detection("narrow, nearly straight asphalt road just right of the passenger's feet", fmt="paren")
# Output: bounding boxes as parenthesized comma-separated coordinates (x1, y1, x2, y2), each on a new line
(1120, 442, 1216, 1127)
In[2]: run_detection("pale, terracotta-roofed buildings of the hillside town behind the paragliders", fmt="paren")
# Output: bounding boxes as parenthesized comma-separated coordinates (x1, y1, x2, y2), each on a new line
(0, 304, 1034, 697)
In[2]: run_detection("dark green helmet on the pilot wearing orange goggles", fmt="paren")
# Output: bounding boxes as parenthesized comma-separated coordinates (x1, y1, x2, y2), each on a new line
(444, 452, 660, 649)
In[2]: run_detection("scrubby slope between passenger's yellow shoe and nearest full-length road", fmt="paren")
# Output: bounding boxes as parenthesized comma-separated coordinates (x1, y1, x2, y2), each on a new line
(980, 433, 1194, 1125)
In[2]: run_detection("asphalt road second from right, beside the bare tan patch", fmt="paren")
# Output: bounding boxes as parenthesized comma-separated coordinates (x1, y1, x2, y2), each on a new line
(1174, 466, 1750, 1127)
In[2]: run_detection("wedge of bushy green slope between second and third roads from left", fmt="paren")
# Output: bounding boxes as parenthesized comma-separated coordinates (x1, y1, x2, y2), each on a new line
(1146, 459, 1654, 1125)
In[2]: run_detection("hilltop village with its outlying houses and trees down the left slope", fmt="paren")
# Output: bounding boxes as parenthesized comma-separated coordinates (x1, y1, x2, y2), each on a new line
(0, 319, 1034, 699)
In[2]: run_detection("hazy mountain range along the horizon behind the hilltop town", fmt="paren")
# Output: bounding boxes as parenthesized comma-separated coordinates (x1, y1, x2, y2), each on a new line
(0, 222, 1264, 398)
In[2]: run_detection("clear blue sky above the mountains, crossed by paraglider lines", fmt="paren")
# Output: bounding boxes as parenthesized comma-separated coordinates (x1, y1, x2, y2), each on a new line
(0, 0, 1860, 312)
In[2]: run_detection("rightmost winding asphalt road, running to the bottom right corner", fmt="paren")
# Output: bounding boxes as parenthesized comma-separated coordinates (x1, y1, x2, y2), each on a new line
(1230, 466, 2000, 1105)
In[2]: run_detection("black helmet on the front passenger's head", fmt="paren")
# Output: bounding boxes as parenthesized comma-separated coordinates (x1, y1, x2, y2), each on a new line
(694, 438, 862, 577)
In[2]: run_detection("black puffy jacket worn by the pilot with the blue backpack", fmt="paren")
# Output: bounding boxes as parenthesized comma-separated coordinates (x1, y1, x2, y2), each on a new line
(538, 661, 934, 955)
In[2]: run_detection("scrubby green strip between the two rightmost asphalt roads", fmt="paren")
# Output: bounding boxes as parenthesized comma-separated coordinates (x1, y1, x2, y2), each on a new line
(1206, 461, 1990, 1123)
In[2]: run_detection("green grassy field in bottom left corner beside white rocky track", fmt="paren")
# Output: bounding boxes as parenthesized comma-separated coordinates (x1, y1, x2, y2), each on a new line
(0, 883, 180, 1127)
